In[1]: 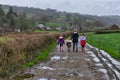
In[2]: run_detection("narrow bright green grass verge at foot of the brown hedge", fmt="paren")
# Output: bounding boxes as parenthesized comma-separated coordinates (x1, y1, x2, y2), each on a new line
(23, 42, 57, 68)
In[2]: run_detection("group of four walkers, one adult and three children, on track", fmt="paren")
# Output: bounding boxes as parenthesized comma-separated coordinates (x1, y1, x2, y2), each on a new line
(58, 30, 86, 52)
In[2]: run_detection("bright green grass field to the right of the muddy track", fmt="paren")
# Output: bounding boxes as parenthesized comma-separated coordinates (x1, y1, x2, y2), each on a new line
(87, 33, 120, 58)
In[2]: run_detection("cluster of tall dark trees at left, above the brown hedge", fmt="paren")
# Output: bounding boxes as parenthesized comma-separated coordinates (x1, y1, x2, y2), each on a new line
(0, 5, 30, 31)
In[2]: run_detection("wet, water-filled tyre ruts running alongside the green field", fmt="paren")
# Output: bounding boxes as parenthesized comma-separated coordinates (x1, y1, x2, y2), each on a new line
(87, 45, 120, 80)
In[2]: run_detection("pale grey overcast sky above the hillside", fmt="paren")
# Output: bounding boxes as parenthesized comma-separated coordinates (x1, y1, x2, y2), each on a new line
(0, 0, 120, 15)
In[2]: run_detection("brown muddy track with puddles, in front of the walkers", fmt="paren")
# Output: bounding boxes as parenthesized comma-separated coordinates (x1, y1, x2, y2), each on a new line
(15, 42, 110, 80)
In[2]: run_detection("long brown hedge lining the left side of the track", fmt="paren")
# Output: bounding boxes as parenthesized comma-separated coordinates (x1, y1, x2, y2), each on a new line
(0, 33, 70, 78)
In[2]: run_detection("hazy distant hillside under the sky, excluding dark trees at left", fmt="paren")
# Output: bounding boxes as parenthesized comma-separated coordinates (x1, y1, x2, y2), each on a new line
(2, 5, 120, 30)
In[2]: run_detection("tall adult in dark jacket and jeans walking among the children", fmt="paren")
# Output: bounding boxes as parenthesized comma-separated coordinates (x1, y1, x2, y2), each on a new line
(71, 30, 79, 52)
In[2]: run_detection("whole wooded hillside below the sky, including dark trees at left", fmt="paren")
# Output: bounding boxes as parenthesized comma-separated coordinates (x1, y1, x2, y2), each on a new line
(0, 5, 120, 31)
